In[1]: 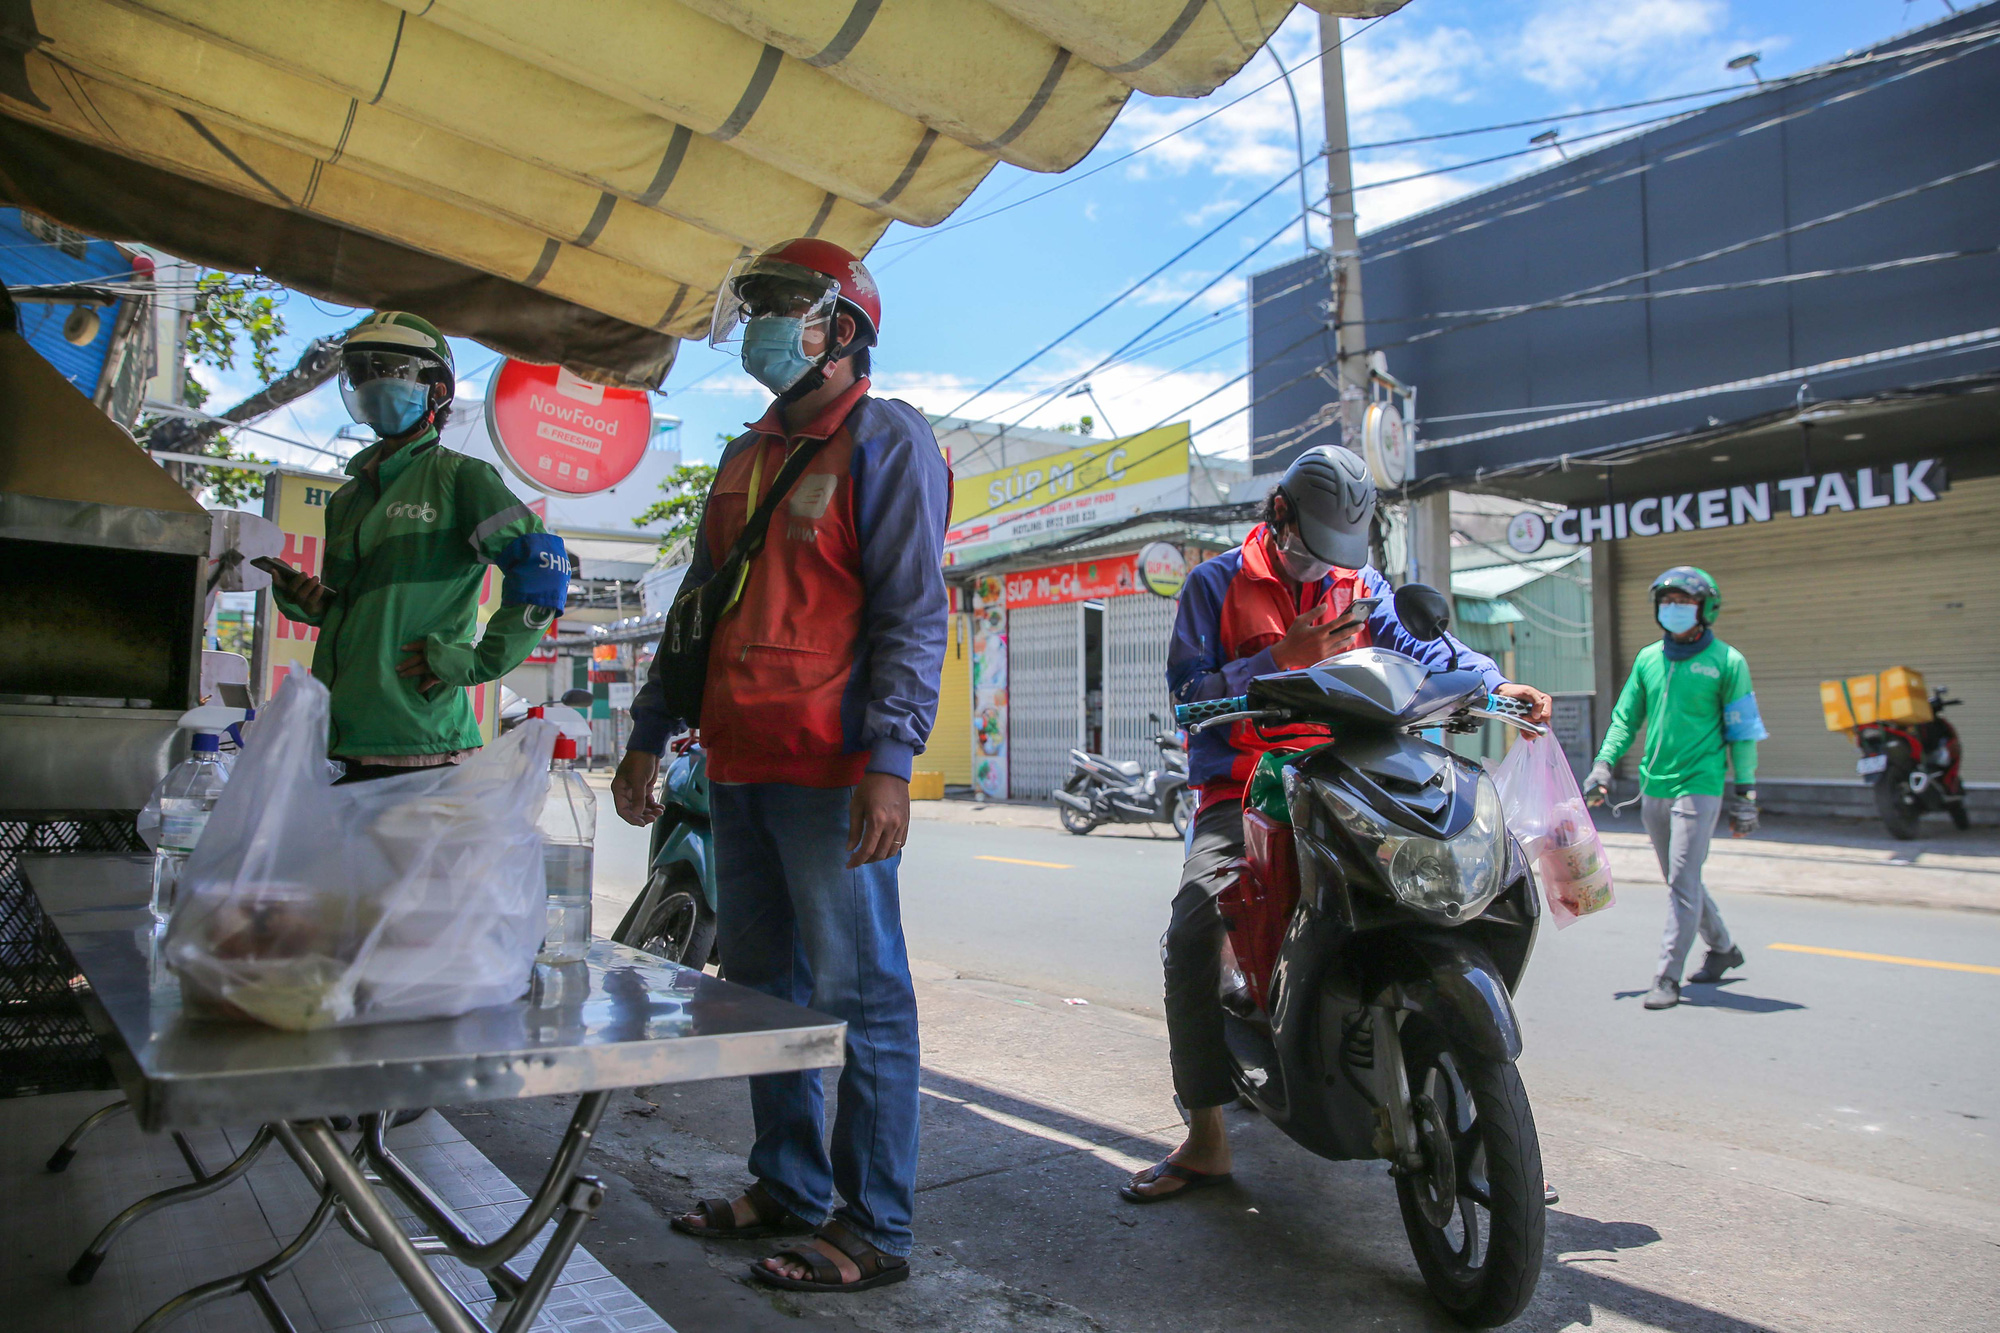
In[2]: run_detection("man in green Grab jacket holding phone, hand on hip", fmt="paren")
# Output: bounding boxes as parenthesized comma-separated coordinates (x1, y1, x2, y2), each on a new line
(254, 310, 570, 783)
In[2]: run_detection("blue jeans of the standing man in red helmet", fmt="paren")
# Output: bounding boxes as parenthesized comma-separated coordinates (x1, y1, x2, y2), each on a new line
(708, 783, 918, 1255)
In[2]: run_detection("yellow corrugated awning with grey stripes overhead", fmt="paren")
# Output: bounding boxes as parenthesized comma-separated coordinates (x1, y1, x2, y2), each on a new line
(0, 0, 1402, 382)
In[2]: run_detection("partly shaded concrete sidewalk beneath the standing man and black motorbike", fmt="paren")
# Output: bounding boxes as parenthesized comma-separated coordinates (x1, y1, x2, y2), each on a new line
(448, 948, 2000, 1333)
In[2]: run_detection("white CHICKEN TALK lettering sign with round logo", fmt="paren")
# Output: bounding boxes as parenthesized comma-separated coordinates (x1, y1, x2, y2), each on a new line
(1506, 458, 1950, 554)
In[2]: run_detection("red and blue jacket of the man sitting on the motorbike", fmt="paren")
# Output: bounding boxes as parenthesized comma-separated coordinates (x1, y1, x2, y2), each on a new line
(1166, 522, 1506, 805)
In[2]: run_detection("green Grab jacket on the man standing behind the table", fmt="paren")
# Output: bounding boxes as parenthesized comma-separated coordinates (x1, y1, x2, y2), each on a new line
(272, 430, 568, 757)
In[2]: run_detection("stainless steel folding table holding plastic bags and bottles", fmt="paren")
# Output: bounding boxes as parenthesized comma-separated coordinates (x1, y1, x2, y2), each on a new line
(20, 855, 846, 1333)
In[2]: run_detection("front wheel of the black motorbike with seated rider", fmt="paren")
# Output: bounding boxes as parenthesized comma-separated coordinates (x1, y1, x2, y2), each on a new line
(1396, 1017, 1548, 1329)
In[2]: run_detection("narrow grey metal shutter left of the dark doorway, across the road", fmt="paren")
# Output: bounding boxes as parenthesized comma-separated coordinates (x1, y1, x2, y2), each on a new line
(1006, 602, 1084, 801)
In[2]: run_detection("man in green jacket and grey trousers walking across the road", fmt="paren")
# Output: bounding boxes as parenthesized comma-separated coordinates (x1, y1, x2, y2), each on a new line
(1584, 564, 1768, 1009)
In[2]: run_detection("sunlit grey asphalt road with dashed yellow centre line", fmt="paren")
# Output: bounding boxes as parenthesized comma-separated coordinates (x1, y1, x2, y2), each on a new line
(902, 821, 2000, 1201)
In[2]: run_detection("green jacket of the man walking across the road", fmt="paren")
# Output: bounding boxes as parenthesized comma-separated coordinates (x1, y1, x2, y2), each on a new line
(1598, 634, 1768, 801)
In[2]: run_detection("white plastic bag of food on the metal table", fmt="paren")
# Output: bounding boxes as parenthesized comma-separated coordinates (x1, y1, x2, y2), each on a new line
(166, 673, 556, 1031)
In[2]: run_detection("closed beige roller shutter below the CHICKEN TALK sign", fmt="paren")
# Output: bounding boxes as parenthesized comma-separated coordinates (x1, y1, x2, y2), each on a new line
(1606, 476, 2000, 783)
